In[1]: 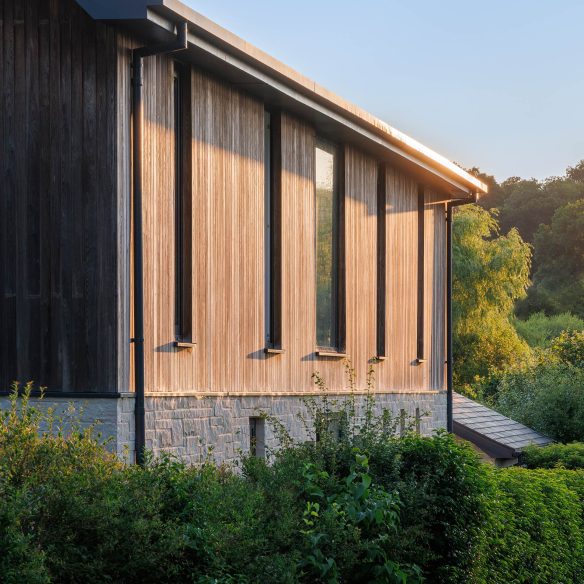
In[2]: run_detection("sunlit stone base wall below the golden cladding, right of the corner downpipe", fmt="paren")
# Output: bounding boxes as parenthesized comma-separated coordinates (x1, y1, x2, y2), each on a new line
(145, 392, 446, 463)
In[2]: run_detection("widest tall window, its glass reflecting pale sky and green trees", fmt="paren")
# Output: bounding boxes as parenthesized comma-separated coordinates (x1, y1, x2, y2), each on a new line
(315, 139, 344, 352)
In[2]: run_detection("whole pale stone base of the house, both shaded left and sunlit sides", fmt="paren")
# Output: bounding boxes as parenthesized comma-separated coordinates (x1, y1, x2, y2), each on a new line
(0, 392, 446, 464)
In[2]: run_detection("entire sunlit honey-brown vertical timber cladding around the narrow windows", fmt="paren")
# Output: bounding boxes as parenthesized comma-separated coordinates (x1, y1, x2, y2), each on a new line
(138, 56, 445, 394)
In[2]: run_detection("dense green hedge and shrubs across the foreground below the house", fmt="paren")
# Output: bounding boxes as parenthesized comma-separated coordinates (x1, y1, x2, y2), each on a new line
(0, 386, 584, 584)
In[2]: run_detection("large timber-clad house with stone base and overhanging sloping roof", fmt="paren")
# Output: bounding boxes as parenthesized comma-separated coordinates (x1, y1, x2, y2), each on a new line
(0, 0, 486, 461)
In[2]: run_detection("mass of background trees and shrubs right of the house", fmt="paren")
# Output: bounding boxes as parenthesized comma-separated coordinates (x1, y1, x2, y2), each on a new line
(453, 161, 584, 442)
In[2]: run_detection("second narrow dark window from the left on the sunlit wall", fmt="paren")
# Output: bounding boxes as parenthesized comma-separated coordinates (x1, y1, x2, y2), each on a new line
(264, 112, 282, 352)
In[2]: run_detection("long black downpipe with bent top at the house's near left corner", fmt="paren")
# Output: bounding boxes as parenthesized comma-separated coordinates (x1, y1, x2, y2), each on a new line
(130, 21, 188, 465)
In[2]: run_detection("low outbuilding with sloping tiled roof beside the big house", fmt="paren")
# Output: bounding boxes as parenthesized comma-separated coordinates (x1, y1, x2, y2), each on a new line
(453, 392, 553, 467)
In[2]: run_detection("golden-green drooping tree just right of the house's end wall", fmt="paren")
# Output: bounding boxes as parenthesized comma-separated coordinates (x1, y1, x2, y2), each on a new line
(453, 205, 531, 385)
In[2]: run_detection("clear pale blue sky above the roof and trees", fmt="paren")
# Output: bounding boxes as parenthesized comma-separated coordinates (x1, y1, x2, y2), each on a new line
(183, 0, 584, 180)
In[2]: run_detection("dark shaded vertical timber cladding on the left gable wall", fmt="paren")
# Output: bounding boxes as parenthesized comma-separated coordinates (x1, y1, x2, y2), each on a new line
(0, 0, 118, 392)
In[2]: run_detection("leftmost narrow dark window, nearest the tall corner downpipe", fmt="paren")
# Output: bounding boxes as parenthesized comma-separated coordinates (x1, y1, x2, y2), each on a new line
(173, 63, 192, 343)
